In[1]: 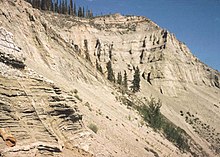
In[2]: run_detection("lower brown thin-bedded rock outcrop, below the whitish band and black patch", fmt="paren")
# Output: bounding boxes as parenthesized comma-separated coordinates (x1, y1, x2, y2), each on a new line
(0, 74, 82, 156)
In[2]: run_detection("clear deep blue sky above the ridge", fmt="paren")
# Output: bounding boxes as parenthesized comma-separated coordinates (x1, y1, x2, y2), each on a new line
(75, 0, 220, 71)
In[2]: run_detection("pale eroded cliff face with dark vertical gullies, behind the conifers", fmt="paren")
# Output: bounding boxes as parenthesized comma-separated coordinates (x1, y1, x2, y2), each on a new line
(46, 14, 219, 96)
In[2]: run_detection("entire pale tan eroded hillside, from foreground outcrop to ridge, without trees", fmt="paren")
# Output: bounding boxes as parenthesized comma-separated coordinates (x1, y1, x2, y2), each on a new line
(0, 0, 220, 157)
